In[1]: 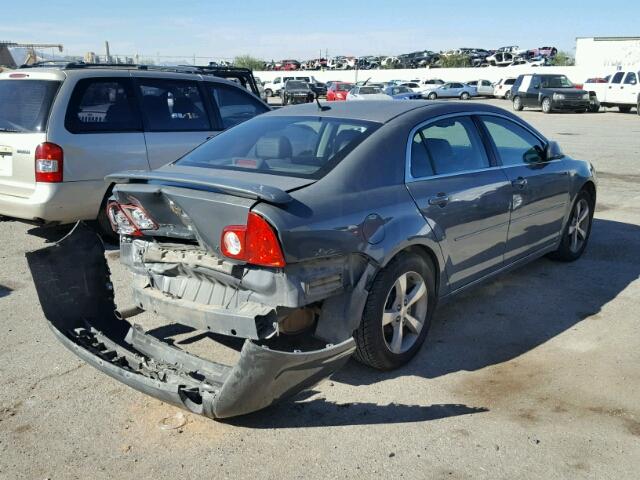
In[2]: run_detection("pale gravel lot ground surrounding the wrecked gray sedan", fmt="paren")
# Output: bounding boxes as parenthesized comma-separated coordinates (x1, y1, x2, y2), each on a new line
(0, 100, 640, 480)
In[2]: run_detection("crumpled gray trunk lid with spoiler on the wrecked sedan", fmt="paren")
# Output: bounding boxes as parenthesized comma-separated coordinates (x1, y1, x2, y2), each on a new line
(107, 166, 314, 256)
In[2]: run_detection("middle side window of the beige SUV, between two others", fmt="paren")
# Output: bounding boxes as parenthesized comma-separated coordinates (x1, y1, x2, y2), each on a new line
(138, 78, 211, 132)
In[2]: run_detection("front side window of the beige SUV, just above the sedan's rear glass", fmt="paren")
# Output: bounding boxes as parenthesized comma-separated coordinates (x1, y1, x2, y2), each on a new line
(205, 83, 269, 130)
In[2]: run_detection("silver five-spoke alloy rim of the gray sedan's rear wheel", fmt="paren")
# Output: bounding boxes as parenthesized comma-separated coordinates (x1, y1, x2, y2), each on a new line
(382, 271, 429, 354)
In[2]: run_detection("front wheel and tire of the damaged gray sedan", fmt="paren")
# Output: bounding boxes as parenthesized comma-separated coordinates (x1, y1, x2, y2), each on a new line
(549, 190, 593, 262)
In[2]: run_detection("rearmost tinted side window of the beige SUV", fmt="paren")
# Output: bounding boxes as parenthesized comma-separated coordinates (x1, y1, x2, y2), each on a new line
(65, 78, 142, 133)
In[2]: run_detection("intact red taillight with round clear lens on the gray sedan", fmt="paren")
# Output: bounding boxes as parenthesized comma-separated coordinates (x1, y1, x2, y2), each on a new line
(220, 212, 286, 267)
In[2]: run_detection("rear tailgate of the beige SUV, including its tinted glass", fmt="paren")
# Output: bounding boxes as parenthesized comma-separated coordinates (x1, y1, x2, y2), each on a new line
(0, 76, 61, 197)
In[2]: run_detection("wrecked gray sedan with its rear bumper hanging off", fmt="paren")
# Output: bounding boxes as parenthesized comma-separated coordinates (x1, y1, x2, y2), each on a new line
(28, 100, 596, 418)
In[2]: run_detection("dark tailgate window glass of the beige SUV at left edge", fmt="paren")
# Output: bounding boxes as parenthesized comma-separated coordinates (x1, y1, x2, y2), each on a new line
(0, 80, 60, 133)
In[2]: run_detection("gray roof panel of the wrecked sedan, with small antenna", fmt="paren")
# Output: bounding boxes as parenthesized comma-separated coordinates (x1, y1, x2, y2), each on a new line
(260, 100, 505, 123)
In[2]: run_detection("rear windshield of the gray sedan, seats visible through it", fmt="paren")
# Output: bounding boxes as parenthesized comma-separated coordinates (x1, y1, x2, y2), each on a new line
(176, 117, 379, 179)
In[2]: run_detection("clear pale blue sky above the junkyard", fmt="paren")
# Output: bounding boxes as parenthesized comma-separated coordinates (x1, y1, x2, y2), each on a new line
(0, 0, 640, 60)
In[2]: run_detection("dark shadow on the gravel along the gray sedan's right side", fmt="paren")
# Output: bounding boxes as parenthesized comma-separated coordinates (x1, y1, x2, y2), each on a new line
(332, 219, 640, 385)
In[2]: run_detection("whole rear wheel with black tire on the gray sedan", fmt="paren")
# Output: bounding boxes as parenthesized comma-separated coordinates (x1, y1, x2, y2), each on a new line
(354, 253, 436, 370)
